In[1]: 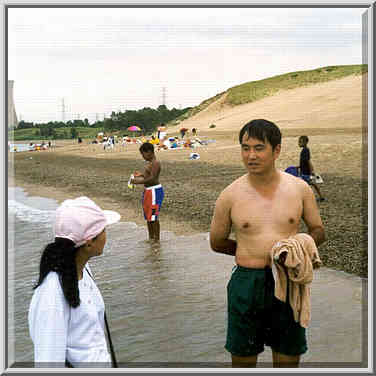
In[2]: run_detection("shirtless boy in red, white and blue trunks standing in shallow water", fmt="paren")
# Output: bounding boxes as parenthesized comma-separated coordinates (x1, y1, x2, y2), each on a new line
(131, 142, 164, 242)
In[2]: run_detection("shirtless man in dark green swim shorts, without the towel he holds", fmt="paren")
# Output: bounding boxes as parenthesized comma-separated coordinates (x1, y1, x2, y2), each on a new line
(210, 119, 325, 367)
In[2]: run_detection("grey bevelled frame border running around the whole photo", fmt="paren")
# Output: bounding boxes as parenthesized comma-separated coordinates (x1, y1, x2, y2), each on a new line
(0, 0, 375, 375)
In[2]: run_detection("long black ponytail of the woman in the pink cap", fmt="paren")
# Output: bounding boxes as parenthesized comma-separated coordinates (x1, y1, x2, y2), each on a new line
(34, 238, 80, 307)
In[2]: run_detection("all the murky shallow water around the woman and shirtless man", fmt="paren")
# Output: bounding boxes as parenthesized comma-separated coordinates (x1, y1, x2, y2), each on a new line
(7, 188, 367, 369)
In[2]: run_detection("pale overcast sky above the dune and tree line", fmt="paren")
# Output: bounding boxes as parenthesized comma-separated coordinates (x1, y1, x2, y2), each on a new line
(6, 7, 366, 123)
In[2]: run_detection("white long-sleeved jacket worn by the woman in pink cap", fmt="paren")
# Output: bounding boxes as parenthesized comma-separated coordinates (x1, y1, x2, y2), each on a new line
(28, 264, 111, 368)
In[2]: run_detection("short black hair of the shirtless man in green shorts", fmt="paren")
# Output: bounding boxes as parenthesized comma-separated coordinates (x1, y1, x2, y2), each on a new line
(239, 119, 282, 150)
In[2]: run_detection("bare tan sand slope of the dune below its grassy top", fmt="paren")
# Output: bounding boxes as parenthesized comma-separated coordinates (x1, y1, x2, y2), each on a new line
(171, 74, 368, 131)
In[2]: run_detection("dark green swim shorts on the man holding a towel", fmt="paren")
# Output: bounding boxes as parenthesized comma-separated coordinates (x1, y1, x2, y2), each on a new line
(225, 265, 307, 356)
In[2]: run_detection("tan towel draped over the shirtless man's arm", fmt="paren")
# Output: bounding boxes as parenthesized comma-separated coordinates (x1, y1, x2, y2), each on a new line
(271, 233, 322, 328)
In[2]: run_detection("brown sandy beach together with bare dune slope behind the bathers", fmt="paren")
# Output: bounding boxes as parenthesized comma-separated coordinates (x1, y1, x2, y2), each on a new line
(8, 76, 367, 277)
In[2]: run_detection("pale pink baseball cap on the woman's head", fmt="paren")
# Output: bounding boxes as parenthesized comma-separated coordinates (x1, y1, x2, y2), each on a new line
(54, 196, 121, 248)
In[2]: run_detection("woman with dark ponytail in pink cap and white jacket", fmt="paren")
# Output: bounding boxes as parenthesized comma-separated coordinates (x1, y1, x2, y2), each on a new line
(28, 197, 120, 367)
